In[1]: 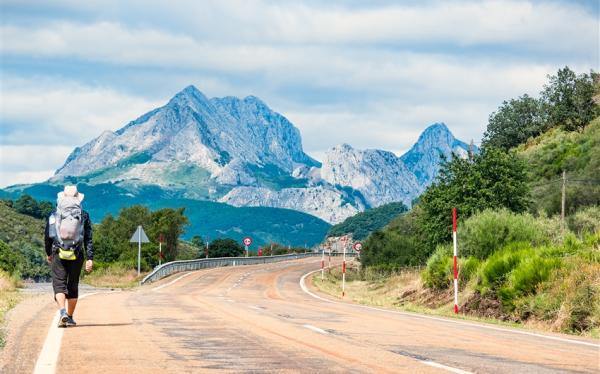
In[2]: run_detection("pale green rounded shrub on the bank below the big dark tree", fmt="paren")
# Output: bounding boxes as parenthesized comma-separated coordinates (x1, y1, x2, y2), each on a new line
(459, 209, 561, 259)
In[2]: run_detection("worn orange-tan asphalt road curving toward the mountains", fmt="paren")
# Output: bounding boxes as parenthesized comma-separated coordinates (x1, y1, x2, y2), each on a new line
(2, 258, 600, 373)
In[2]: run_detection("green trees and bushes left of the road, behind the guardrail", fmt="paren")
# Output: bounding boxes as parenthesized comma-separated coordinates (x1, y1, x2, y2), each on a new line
(0, 195, 314, 292)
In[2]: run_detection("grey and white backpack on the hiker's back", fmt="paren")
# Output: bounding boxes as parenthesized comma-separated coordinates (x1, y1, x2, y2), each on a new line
(48, 196, 83, 260)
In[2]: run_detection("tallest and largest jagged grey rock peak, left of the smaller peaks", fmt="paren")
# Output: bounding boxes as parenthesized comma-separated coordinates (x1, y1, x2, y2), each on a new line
(56, 85, 320, 183)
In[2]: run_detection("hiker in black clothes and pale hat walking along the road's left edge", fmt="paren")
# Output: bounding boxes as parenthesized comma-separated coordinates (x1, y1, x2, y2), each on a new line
(44, 186, 94, 327)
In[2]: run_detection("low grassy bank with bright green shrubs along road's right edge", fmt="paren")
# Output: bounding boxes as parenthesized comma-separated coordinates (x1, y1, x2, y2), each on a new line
(313, 207, 600, 338)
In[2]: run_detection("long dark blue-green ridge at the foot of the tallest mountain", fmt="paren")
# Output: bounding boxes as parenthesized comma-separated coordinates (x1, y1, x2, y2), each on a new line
(3, 183, 330, 247)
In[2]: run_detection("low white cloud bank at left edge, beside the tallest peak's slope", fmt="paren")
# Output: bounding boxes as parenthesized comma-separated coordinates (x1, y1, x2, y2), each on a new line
(0, 78, 164, 147)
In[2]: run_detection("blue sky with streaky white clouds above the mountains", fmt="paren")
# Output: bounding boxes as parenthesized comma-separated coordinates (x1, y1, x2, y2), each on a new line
(0, 0, 600, 187)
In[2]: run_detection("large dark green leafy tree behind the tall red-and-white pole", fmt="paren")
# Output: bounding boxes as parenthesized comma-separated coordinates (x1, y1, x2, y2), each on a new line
(419, 147, 530, 247)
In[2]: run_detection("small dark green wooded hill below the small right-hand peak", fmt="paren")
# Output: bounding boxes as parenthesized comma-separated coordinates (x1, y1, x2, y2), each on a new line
(327, 203, 408, 240)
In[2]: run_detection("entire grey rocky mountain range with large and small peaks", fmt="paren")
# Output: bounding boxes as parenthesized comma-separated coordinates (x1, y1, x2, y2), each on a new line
(44, 86, 476, 223)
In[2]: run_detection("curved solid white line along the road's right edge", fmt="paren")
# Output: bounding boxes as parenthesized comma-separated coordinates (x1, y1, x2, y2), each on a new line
(300, 269, 600, 348)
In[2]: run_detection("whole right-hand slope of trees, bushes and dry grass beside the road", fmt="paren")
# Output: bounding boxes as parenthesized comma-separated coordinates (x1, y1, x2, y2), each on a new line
(324, 67, 600, 338)
